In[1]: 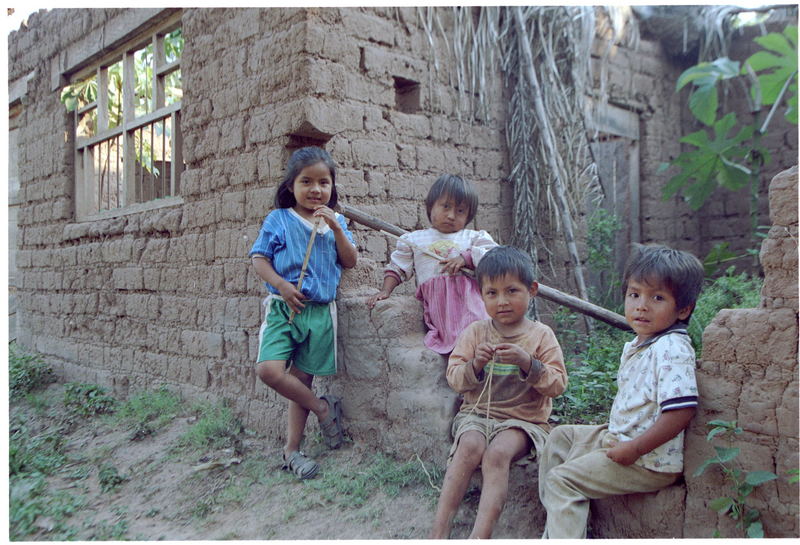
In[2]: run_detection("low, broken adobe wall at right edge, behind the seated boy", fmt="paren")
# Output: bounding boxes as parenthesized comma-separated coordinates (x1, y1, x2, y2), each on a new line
(685, 166, 800, 537)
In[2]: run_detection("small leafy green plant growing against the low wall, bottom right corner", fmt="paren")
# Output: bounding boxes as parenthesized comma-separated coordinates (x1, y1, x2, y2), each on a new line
(694, 420, 778, 538)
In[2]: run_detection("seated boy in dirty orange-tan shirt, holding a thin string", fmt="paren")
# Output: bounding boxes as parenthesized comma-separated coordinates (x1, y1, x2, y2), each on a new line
(429, 246, 567, 539)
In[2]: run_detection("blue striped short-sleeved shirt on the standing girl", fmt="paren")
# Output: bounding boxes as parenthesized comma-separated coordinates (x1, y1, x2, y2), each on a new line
(248, 208, 355, 303)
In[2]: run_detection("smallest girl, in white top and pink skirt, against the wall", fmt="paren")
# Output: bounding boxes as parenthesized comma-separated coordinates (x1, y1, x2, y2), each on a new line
(367, 174, 497, 355)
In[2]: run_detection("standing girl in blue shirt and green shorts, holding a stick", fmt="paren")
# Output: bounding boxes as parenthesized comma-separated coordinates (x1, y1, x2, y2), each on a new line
(250, 147, 357, 479)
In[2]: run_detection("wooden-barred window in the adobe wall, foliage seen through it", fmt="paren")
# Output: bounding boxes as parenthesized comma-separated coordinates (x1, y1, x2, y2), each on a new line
(61, 19, 185, 220)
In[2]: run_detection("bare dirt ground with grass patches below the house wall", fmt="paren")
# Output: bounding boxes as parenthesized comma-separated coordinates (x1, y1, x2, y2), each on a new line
(9, 384, 490, 541)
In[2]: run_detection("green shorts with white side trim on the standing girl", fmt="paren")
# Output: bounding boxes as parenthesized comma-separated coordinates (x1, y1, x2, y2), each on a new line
(258, 295, 336, 376)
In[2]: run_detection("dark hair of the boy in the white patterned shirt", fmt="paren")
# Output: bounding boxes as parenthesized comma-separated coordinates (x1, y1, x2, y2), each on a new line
(622, 244, 705, 316)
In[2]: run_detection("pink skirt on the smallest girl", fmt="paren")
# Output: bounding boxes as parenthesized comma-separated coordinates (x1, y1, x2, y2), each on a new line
(417, 274, 489, 355)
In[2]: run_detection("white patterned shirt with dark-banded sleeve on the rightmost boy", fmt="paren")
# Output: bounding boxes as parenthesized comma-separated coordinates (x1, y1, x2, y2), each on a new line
(608, 324, 697, 473)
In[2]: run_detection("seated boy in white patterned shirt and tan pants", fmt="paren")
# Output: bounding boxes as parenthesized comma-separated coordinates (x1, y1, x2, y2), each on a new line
(539, 245, 704, 539)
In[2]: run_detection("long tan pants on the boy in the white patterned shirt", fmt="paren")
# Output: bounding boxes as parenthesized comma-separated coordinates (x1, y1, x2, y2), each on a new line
(539, 424, 680, 539)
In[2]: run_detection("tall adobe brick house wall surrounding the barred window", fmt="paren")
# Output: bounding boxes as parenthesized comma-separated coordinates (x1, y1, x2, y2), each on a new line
(9, 8, 510, 446)
